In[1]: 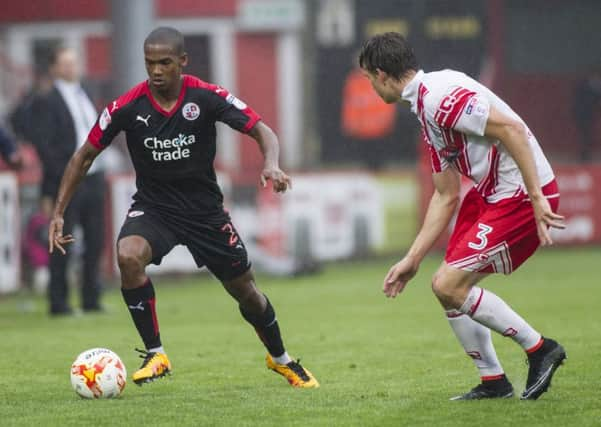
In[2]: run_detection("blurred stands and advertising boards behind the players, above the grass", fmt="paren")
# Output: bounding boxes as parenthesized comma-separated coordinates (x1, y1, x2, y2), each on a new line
(0, 0, 601, 293)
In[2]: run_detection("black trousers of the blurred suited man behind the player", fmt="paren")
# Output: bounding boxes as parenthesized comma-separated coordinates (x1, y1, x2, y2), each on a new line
(48, 172, 106, 313)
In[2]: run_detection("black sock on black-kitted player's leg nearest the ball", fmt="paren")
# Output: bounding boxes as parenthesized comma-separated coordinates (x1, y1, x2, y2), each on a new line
(121, 278, 161, 349)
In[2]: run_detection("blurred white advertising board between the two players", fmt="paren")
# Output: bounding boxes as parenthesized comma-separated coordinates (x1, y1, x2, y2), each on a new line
(255, 172, 384, 260)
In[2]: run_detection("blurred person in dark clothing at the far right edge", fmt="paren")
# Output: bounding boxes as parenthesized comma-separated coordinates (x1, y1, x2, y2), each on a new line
(573, 68, 601, 162)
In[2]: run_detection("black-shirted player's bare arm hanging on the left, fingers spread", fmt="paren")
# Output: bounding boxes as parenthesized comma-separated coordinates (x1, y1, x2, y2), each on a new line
(48, 142, 100, 255)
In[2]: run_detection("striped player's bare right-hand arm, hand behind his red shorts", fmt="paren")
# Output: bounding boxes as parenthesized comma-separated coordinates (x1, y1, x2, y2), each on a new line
(484, 107, 565, 246)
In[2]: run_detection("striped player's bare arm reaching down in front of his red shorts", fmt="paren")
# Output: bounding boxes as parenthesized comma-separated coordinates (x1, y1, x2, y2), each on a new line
(382, 167, 460, 298)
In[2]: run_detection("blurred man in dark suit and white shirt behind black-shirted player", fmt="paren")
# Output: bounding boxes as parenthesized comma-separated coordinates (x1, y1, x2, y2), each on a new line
(30, 47, 105, 315)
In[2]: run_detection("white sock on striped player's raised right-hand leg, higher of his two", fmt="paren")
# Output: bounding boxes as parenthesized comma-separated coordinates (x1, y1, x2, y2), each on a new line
(459, 286, 541, 350)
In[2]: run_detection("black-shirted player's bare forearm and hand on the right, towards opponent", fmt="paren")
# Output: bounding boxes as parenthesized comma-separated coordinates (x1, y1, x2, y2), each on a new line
(248, 121, 292, 193)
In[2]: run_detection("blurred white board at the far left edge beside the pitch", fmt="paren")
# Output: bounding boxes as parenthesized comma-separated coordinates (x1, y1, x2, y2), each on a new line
(0, 172, 21, 294)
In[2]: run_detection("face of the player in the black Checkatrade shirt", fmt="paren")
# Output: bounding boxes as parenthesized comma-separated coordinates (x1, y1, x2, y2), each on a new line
(144, 44, 188, 92)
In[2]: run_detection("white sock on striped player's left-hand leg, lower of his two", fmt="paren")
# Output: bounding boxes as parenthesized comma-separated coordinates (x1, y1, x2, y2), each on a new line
(446, 310, 504, 380)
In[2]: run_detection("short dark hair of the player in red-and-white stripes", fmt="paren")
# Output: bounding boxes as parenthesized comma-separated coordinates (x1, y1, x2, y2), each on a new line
(359, 32, 418, 80)
